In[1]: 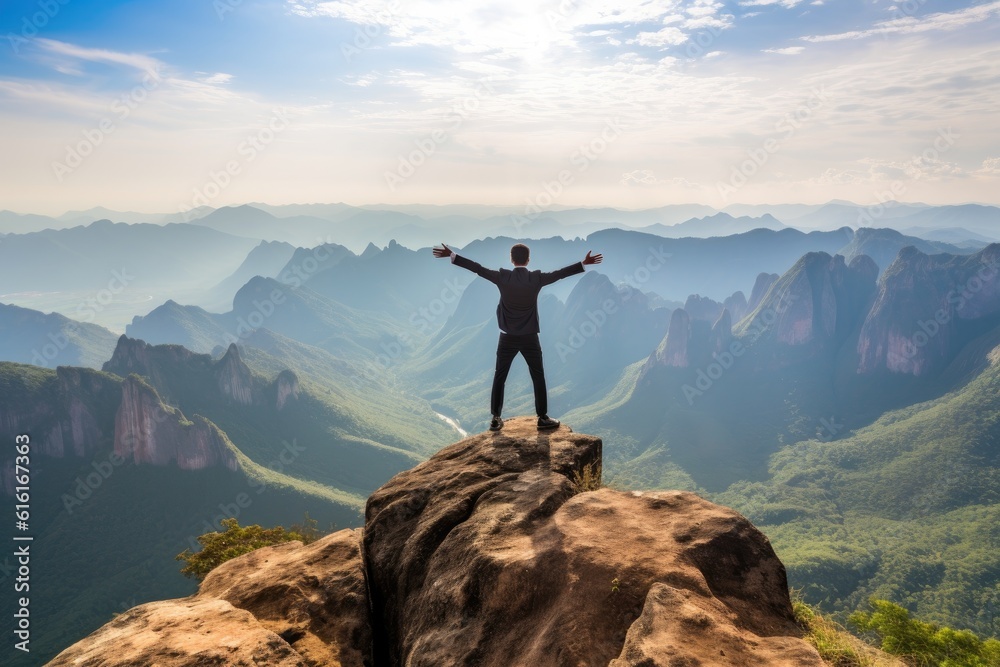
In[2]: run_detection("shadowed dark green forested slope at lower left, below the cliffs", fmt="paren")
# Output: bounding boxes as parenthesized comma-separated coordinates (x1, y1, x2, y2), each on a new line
(2, 453, 362, 665)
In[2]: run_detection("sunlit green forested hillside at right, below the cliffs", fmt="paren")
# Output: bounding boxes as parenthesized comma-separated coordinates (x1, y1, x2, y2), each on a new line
(715, 350, 1000, 636)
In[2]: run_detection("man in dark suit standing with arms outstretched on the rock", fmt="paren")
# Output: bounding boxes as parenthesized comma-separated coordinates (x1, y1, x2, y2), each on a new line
(434, 243, 603, 431)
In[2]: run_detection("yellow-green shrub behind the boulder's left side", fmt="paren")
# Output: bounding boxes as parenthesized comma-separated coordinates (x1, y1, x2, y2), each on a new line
(175, 512, 319, 581)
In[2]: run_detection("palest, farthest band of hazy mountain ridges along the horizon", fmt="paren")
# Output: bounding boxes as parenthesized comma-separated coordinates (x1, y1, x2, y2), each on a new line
(0, 201, 1000, 251)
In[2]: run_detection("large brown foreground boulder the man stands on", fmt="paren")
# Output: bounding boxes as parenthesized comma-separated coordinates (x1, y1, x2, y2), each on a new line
(50, 418, 823, 667)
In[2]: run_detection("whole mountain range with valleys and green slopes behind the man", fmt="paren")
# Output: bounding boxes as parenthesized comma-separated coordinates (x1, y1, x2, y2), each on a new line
(0, 210, 1000, 655)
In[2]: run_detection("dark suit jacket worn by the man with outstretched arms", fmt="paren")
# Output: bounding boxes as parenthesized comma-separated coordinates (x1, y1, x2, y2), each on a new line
(455, 255, 584, 336)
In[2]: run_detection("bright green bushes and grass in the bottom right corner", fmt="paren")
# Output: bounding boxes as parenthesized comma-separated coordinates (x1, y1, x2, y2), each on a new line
(849, 599, 1000, 667)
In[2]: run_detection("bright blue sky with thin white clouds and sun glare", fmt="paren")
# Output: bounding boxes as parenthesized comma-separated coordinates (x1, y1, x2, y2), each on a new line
(0, 0, 1000, 215)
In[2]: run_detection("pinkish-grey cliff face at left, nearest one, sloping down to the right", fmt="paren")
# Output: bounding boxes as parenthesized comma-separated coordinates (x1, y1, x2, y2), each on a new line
(114, 375, 237, 470)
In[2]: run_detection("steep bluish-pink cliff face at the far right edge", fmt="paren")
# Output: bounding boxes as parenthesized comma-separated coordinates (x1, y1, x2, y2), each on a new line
(858, 244, 1000, 376)
